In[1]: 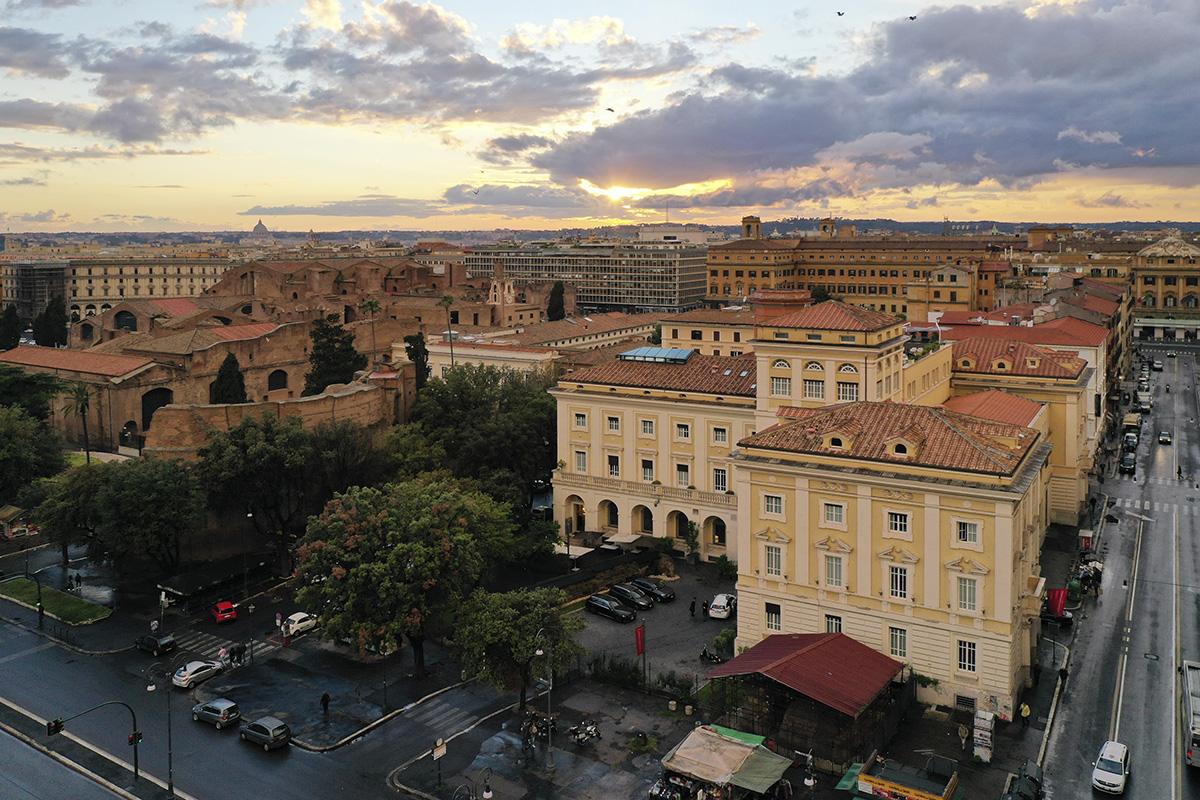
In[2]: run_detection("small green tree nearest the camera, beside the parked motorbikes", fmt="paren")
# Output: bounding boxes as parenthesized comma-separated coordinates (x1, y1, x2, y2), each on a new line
(454, 589, 584, 710)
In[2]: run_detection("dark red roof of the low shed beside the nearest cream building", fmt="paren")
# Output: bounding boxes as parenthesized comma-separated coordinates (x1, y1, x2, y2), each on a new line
(708, 633, 904, 717)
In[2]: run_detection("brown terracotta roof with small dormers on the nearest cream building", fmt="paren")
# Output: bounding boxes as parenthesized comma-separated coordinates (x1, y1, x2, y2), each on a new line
(739, 402, 1038, 475)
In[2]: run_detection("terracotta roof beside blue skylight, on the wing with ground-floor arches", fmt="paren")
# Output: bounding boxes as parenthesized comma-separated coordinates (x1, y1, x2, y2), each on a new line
(559, 354, 757, 397)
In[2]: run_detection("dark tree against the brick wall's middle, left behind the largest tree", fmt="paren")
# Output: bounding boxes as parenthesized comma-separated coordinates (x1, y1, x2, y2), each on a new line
(197, 416, 312, 554)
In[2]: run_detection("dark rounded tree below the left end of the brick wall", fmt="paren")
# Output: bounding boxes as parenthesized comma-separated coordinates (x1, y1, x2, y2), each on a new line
(96, 458, 204, 575)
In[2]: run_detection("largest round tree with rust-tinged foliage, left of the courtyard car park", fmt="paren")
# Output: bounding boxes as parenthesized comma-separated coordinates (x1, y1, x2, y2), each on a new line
(296, 476, 511, 675)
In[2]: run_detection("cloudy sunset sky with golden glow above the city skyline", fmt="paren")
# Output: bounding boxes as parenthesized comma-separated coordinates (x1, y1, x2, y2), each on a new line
(0, 0, 1200, 233)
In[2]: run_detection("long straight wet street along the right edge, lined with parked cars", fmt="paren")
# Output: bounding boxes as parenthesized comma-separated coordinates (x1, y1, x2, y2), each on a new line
(1045, 344, 1200, 800)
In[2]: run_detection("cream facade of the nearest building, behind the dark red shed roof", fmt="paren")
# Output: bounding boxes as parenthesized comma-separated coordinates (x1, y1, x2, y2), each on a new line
(733, 410, 1050, 718)
